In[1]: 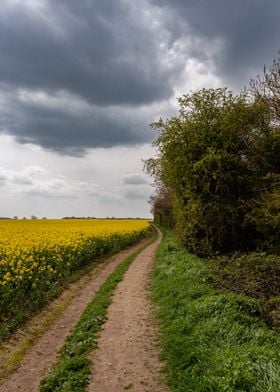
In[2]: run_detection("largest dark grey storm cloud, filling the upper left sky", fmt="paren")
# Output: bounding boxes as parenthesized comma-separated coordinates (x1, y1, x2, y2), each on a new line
(0, 0, 172, 105)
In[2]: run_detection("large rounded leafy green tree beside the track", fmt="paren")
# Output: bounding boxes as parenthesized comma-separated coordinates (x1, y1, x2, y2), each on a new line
(149, 89, 273, 255)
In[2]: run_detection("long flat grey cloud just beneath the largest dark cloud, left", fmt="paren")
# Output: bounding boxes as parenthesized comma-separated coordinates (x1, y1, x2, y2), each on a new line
(0, 94, 153, 155)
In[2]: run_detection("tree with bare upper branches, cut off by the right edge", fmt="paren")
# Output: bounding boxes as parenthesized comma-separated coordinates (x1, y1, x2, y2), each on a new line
(248, 53, 280, 253)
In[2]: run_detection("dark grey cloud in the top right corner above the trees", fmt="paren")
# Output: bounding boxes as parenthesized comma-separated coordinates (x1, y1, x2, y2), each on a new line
(151, 0, 280, 88)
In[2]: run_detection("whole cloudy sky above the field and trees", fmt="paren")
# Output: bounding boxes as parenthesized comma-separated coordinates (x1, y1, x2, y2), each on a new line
(0, 0, 280, 217)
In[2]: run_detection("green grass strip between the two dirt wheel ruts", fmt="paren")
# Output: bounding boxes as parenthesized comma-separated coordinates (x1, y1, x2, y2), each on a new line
(40, 230, 158, 392)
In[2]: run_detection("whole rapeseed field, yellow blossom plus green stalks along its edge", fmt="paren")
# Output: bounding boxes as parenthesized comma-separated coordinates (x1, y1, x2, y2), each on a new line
(0, 219, 150, 342)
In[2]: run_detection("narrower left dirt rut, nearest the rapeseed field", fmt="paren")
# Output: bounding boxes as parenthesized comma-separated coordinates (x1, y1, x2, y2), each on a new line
(0, 236, 151, 392)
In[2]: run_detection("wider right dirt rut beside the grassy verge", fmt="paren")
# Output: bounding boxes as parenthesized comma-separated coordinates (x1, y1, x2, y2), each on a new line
(88, 228, 169, 392)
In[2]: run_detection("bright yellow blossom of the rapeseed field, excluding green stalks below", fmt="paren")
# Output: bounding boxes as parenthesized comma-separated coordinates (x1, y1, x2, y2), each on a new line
(0, 219, 149, 288)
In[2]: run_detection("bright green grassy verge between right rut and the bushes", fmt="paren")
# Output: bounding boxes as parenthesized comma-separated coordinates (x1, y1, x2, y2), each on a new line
(152, 232, 280, 392)
